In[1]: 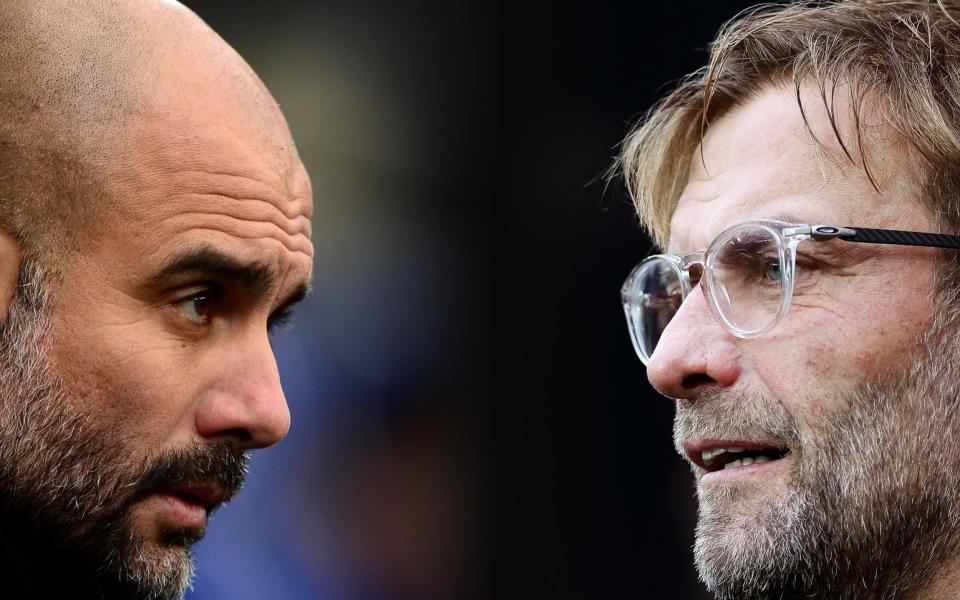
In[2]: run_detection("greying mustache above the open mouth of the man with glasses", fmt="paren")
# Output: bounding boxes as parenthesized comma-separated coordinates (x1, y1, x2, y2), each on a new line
(673, 389, 801, 456)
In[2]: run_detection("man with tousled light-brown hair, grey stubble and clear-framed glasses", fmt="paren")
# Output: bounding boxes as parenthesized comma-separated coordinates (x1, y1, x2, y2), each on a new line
(619, 1, 960, 600)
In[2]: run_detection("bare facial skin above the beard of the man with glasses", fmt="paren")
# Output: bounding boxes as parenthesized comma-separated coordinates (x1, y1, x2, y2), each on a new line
(647, 88, 932, 400)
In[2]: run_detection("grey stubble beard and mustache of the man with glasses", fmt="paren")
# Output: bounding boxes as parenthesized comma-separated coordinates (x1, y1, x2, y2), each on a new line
(674, 311, 960, 600)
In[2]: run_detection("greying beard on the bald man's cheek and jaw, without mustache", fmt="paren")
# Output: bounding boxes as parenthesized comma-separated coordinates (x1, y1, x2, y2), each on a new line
(0, 265, 194, 600)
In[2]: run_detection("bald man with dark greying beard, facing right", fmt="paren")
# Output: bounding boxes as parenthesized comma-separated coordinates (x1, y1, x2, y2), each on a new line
(0, 0, 313, 599)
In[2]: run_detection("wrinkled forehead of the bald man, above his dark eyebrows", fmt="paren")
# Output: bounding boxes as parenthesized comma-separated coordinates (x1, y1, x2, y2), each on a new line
(85, 113, 313, 290)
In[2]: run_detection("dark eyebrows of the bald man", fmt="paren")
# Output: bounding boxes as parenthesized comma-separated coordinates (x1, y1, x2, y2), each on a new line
(146, 246, 310, 312)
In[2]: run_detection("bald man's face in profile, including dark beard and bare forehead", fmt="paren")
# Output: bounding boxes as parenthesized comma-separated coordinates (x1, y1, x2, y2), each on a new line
(0, 3, 313, 599)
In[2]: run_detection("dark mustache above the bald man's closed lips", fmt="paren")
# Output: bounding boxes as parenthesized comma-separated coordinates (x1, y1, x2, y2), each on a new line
(132, 442, 250, 502)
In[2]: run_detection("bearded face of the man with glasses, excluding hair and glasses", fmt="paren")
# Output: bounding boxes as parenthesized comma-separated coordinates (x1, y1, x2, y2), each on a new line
(647, 86, 960, 600)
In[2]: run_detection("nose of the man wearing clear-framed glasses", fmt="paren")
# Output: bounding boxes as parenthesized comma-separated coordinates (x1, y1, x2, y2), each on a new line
(647, 286, 740, 399)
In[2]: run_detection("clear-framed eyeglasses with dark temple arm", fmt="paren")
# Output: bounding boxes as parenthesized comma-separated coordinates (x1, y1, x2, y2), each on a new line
(621, 220, 960, 364)
